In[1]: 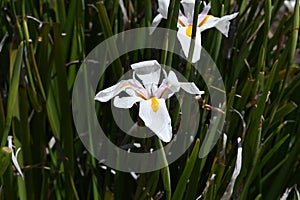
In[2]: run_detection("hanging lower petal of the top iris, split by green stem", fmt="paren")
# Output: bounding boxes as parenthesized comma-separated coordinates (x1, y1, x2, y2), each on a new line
(177, 27, 202, 63)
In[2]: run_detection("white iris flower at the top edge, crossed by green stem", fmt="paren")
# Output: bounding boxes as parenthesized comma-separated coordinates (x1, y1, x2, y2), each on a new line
(177, 0, 238, 63)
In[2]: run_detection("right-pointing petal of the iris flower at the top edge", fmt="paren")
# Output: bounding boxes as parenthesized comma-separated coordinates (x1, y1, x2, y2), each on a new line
(199, 13, 238, 37)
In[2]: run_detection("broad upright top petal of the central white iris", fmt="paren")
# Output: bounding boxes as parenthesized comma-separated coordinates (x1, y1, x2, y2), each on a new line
(131, 60, 161, 88)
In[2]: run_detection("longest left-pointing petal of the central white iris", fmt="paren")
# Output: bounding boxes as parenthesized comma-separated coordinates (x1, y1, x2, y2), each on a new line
(94, 79, 133, 102)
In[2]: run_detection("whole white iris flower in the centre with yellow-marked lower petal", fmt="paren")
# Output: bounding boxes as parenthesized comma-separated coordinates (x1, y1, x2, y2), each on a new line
(95, 60, 204, 142)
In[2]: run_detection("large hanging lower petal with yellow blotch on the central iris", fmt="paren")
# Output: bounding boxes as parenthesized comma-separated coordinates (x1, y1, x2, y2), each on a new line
(139, 98, 172, 142)
